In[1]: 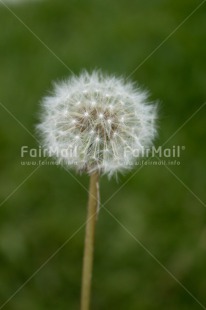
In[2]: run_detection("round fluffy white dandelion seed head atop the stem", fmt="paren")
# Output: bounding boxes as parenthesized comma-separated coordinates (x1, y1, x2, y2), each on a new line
(37, 71, 156, 175)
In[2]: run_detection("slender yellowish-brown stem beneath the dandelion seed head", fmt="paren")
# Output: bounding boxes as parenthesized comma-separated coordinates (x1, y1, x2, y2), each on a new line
(81, 173, 99, 310)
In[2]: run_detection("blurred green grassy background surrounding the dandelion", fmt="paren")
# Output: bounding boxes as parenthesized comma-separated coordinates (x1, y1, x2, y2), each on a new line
(0, 0, 206, 310)
